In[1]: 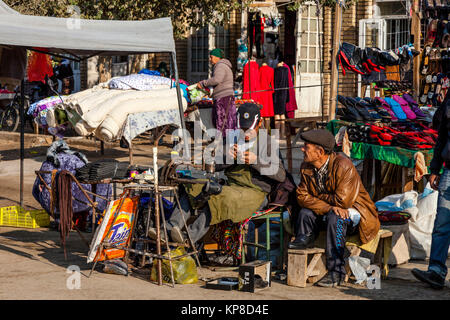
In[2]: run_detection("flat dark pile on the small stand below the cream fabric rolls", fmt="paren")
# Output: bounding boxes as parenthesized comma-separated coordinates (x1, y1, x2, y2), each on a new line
(75, 159, 129, 181)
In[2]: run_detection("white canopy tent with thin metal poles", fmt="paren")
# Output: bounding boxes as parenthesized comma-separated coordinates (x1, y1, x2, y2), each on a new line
(0, 0, 187, 205)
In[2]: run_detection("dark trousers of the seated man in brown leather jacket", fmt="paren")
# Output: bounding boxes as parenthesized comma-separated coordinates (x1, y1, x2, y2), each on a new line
(295, 208, 358, 275)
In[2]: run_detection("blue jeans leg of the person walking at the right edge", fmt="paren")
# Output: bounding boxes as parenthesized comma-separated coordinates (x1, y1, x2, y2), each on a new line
(428, 169, 450, 279)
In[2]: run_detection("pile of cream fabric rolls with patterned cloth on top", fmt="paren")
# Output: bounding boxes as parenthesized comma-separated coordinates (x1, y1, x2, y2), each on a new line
(28, 73, 188, 141)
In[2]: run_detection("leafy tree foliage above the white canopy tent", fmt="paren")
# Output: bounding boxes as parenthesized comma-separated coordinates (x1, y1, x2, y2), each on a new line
(4, 0, 348, 38)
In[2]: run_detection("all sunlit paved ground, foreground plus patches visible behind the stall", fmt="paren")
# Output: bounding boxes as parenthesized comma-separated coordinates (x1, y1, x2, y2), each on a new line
(0, 132, 450, 300)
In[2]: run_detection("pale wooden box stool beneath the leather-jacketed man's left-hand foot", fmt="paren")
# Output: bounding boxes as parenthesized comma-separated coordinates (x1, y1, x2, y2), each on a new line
(287, 248, 327, 288)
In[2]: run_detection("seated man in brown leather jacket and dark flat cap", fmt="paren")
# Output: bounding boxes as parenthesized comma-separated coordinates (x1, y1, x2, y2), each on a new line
(289, 129, 380, 287)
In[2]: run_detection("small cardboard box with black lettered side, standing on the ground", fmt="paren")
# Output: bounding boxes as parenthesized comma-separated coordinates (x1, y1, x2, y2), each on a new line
(238, 260, 272, 293)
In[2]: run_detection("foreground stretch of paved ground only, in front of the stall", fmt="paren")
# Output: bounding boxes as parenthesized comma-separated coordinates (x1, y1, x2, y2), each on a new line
(0, 227, 450, 300)
